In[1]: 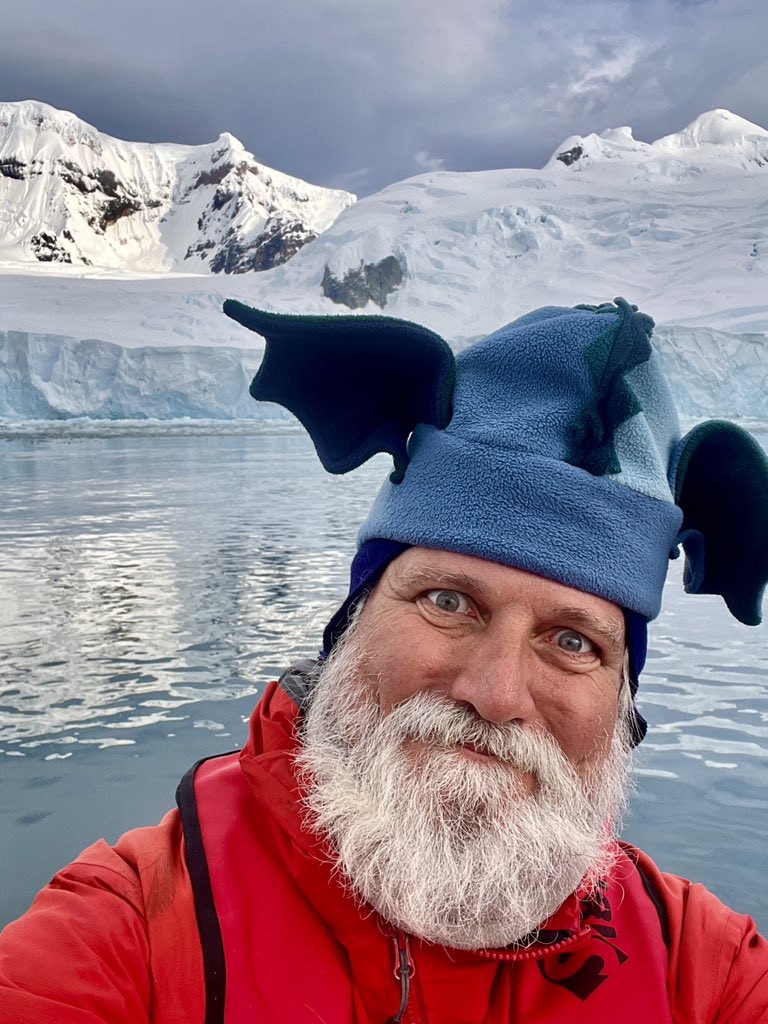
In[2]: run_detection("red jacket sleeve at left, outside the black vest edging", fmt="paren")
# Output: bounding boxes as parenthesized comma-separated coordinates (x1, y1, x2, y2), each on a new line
(0, 811, 204, 1024)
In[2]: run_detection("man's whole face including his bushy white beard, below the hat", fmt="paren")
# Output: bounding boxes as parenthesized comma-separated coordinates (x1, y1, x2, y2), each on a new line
(298, 549, 629, 948)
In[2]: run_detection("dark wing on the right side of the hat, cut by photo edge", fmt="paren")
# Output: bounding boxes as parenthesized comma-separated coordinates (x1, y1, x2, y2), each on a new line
(670, 420, 768, 626)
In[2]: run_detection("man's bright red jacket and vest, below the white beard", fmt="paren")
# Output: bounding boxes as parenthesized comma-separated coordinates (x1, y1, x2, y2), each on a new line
(0, 686, 768, 1024)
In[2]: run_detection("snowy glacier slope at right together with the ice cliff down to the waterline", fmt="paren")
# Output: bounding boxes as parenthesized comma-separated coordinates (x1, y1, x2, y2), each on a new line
(0, 111, 768, 422)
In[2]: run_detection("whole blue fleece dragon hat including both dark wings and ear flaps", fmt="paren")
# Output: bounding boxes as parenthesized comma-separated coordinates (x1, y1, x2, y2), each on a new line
(224, 299, 768, 745)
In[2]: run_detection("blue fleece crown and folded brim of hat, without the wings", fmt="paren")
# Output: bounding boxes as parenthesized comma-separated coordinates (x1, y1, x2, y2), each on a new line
(358, 302, 682, 620)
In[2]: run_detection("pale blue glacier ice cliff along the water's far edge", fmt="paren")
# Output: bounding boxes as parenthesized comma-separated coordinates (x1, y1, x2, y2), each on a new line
(0, 327, 768, 423)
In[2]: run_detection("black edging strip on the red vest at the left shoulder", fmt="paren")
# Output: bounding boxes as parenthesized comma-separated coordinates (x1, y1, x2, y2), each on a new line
(176, 752, 236, 1024)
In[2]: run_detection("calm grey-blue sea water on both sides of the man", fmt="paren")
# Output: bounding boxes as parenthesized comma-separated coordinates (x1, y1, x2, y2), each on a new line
(0, 425, 768, 931)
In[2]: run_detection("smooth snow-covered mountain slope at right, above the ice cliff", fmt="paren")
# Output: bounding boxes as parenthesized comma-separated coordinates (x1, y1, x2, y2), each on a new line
(247, 111, 768, 342)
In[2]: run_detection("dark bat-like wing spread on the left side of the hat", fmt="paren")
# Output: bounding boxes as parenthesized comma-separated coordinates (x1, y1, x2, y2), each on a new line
(224, 299, 456, 480)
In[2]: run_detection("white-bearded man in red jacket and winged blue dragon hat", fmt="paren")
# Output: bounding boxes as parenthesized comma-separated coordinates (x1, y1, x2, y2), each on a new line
(0, 300, 768, 1024)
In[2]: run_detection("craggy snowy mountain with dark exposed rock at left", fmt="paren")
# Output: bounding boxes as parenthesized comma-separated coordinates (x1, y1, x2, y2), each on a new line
(0, 100, 354, 273)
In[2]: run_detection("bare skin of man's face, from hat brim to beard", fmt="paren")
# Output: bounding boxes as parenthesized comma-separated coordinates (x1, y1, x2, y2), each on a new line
(357, 548, 625, 781)
